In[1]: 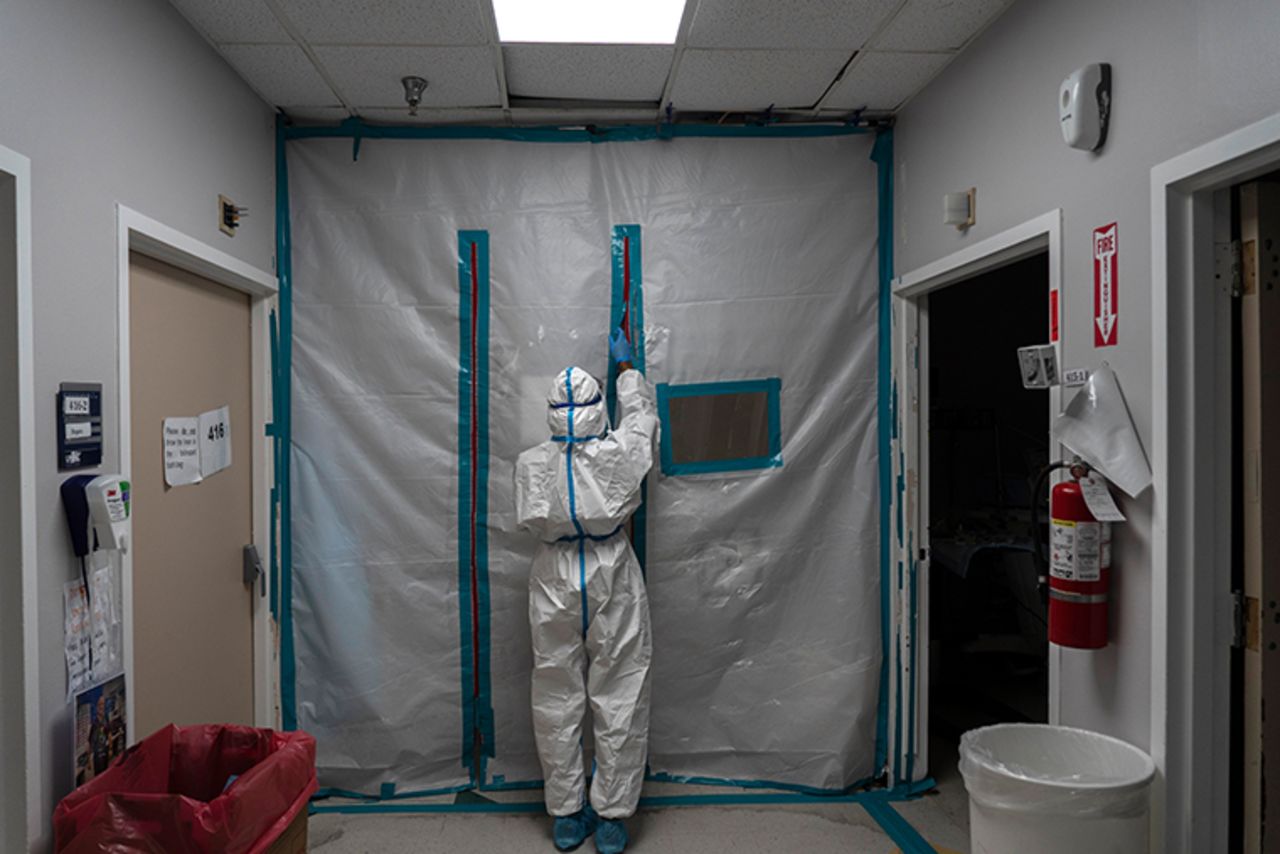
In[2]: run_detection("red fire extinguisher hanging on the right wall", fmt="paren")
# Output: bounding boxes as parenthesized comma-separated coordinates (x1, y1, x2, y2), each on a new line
(1048, 465, 1111, 649)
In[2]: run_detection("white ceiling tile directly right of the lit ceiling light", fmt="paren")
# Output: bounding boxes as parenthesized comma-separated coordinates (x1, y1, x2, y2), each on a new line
(686, 0, 900, 50)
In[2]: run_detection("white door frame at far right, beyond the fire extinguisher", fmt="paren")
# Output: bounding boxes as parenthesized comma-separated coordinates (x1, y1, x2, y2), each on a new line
(1151, 115, 1280, 854)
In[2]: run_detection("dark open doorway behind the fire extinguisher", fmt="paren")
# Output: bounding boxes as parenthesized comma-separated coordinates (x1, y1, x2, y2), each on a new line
(922, 251, 1050, 785)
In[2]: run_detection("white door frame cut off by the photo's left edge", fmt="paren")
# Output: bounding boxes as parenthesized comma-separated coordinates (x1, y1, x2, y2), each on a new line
(0, 146, 45, 849)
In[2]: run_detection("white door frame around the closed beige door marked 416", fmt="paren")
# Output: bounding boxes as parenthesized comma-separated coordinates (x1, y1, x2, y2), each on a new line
(115, 204, 278, 744)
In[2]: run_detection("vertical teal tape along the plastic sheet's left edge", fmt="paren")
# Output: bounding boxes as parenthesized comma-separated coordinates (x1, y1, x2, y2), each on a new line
(275, 115, 298, 730)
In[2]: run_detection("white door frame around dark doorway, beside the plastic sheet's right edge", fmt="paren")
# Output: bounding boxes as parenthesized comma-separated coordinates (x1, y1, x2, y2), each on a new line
(892, 207, 1066, 782)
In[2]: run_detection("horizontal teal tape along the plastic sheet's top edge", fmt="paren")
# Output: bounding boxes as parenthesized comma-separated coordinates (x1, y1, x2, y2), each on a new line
(287, 118, 873, 145)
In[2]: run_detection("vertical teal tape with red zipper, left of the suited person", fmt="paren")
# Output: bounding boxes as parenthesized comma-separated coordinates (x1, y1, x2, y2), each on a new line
(458, 230, 494, 784)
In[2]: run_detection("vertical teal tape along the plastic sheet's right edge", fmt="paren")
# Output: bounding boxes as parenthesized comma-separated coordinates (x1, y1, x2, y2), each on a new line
(872, 129, 893, 768)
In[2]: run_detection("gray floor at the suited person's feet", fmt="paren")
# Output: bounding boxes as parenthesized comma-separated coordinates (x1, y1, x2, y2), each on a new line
(310, 758, 969, 854)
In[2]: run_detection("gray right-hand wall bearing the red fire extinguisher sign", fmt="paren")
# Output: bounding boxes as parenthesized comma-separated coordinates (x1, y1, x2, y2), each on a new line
(895, 0, 1280, 746)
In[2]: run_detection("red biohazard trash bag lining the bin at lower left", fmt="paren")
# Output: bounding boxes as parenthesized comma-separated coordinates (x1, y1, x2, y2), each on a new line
(54, 725, 316, 854)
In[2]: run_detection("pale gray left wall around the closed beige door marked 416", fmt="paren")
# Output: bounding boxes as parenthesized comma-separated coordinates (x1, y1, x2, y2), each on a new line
(0, 0, 274, 850)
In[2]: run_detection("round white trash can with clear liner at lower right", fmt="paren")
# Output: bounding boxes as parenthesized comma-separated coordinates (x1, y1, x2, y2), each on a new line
(960, 723, 1156, 854)
